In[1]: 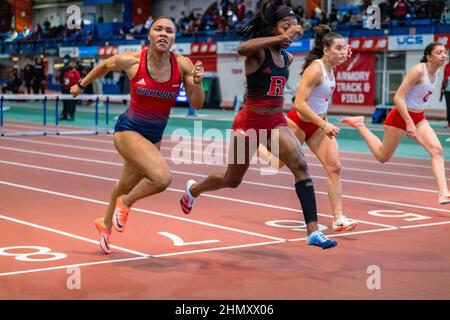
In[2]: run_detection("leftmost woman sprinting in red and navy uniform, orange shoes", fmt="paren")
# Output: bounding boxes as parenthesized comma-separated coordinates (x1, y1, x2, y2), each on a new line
(70, 17, 205, 253)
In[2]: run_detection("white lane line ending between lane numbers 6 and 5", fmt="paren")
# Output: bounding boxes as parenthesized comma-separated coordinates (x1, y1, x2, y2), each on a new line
(0, 160, 398, 227)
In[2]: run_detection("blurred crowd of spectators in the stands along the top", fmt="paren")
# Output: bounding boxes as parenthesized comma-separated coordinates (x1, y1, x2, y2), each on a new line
(0, 0, 450, 45)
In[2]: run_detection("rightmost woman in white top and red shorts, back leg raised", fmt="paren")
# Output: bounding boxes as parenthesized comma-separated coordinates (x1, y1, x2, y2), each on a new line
(340, 42, 450, 204)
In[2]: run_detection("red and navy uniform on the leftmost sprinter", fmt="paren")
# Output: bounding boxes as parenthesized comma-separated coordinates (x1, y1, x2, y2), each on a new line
(114, 48, 182, 143)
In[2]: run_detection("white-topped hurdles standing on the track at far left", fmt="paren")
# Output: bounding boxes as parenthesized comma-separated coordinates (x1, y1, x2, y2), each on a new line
(0, 94, 130, 137)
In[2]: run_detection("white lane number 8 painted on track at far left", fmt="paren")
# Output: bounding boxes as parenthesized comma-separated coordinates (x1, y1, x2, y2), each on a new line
(0, 246, 67, 262)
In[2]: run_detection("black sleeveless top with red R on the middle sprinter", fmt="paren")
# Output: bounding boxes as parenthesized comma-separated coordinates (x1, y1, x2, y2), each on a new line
(245, 49, 289, 109)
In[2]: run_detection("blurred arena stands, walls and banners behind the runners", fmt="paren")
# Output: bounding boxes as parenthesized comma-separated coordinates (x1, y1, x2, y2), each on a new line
(0, 0, 450, 119)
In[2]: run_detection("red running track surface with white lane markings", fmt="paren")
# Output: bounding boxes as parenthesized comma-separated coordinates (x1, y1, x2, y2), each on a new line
(0, 136, 450, 299)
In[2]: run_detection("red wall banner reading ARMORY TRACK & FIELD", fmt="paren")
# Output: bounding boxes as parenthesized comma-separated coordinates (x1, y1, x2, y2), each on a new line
(333, 52, 375, 106)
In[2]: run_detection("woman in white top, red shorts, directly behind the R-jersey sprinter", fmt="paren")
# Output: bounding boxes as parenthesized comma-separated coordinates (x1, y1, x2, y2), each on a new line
(259, 25, 357, 231)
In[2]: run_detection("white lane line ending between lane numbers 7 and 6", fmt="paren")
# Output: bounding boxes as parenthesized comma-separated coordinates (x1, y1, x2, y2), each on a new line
(0, 180, 284, 243)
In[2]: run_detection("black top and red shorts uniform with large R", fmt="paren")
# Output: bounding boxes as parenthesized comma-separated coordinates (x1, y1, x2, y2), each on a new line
(232, 49, 289, 139)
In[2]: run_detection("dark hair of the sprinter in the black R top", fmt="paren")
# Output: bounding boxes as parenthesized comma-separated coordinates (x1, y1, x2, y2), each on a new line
(237, 0, 296, 40)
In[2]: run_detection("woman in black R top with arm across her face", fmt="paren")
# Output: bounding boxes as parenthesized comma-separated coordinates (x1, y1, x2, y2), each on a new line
(180, 0, 337, 249)
